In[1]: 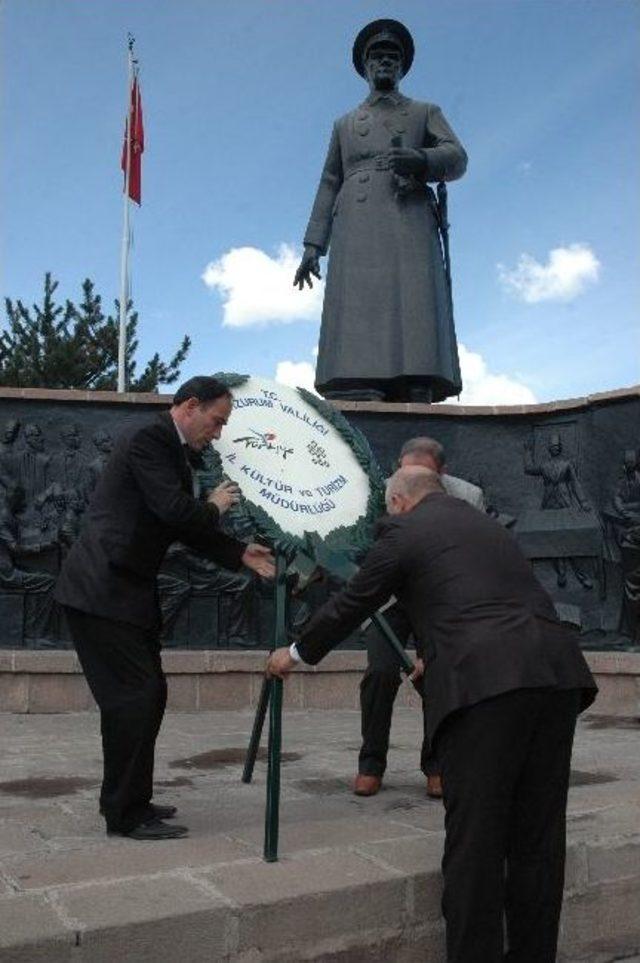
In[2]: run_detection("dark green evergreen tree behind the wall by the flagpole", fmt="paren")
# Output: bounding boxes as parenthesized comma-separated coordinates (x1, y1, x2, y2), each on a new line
(0, 273, 191, 391)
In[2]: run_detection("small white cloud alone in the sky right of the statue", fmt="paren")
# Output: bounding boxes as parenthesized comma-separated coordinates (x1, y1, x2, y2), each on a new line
(498, 244, 600, 304)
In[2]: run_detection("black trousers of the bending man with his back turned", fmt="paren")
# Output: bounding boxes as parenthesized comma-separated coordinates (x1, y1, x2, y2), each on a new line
(437, 689, 579, 963)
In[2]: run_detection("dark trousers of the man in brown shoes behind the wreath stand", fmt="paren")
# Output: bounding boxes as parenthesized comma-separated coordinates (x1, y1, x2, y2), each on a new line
(358, 605, 439, 778)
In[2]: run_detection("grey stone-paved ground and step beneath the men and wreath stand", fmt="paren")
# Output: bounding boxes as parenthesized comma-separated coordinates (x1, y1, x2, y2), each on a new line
(0, 708, 640, 963)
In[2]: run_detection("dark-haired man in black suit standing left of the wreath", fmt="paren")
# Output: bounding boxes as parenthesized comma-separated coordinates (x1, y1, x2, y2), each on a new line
(55, 377, 274, 840)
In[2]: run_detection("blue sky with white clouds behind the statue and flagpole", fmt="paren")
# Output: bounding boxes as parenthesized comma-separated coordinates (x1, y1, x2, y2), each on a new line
(0, 0, 640, 403)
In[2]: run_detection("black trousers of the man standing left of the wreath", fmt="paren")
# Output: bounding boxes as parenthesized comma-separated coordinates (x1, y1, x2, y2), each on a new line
(66, 608, 167, 832)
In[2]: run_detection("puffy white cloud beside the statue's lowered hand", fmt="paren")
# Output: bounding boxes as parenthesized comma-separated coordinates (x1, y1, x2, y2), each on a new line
(202, 244, 324, 328)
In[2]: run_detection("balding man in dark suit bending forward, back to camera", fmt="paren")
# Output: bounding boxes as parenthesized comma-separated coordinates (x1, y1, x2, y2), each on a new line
(268, 467, 596, 963)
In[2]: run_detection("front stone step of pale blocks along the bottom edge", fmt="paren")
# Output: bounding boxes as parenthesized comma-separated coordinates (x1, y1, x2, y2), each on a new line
(0, 834, 640, 963)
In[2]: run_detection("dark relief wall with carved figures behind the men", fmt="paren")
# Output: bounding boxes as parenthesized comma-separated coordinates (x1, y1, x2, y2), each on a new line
(0, 389, 640, 648)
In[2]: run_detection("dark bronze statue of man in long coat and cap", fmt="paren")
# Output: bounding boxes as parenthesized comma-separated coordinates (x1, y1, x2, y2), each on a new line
(294, 20, 467, 402)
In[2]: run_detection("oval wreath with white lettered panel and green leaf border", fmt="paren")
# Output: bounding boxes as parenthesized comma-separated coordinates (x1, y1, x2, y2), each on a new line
(210, 374, 381, 541)
